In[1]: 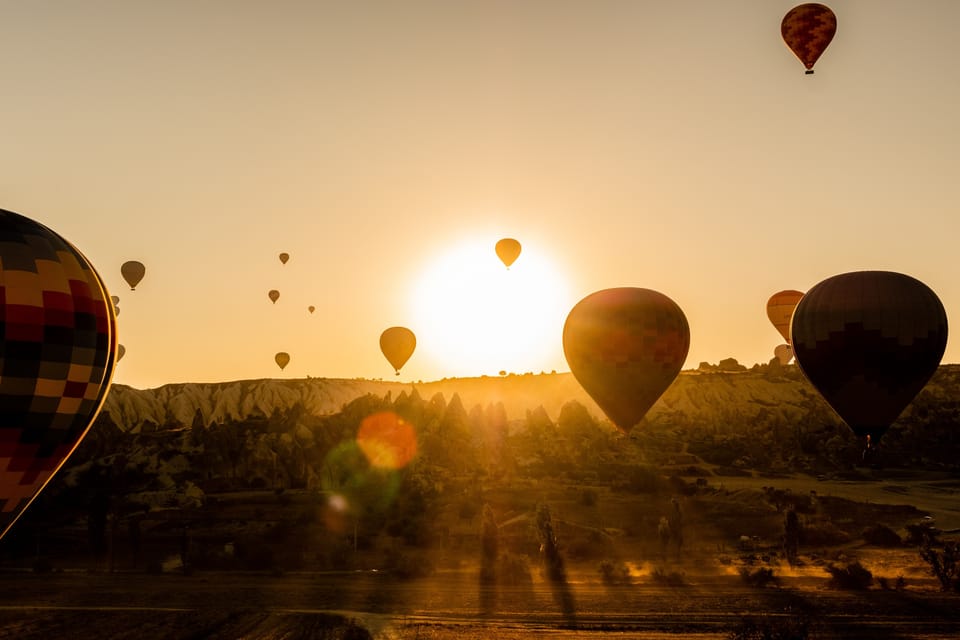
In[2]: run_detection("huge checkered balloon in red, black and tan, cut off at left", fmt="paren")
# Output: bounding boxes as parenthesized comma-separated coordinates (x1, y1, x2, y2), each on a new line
(0, 209, 117, 537)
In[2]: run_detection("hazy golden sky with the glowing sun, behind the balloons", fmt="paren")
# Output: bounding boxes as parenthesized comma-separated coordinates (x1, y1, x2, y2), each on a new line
(0, 0, 960, 387)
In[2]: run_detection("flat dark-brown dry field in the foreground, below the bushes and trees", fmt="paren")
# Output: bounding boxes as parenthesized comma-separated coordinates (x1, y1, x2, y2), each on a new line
(0, 571, 960, 640)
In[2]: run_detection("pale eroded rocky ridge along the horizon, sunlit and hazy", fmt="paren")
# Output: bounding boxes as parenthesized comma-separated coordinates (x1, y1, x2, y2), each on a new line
(103, 360, 818, 433)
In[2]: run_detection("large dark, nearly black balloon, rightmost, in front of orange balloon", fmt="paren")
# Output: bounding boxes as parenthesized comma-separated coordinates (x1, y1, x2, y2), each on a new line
(791, 271, 947, 443)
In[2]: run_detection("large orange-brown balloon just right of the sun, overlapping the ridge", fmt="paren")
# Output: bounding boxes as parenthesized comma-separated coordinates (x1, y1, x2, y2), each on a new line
(563, 287, 690, 433)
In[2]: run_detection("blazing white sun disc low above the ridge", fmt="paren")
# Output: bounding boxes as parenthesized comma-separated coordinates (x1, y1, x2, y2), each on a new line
(412, 238, 573, 377)
